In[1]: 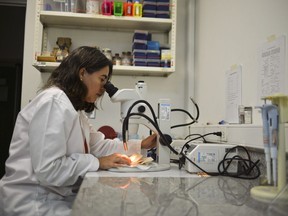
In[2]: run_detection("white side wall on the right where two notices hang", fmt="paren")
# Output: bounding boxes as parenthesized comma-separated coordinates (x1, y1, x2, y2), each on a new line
(190, 0, 288, 124)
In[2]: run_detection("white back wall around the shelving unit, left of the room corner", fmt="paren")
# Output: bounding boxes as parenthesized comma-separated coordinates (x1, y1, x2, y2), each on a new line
(21, 0, 192, 136)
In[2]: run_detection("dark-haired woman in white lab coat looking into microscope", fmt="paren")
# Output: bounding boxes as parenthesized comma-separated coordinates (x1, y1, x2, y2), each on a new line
(0, 47, 156, 216)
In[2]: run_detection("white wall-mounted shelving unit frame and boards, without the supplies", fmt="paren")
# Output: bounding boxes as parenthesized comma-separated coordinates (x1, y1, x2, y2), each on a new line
(33, 0, 177, 77)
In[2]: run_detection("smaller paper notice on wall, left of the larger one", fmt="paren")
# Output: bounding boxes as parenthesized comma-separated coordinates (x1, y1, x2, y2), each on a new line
(226, 65, 242, 124)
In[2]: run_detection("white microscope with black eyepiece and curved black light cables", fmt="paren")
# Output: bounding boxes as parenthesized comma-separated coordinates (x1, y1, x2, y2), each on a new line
(104, 81, 171, 171)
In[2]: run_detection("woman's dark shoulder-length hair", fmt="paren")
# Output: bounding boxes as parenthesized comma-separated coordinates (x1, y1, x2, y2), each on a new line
(42, 46, 113, 112)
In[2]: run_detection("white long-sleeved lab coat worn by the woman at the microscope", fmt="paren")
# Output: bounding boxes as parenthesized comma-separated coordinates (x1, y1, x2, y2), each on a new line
(0, 87, 141, 216)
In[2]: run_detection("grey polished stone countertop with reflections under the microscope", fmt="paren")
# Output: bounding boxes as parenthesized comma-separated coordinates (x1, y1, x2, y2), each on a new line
(72, 165, 288, 216)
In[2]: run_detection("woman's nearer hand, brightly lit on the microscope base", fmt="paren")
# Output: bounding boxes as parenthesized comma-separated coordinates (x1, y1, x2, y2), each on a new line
(98, 153, 131, 170)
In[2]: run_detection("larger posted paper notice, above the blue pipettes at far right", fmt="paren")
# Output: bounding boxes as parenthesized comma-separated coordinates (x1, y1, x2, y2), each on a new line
(258, 35, 288, 99)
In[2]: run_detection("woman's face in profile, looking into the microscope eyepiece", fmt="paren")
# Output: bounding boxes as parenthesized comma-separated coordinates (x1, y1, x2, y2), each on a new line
(80, 66, 109, 103)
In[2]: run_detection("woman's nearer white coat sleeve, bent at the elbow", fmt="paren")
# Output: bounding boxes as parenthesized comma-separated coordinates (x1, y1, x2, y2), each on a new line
(29, 98, 99, 186)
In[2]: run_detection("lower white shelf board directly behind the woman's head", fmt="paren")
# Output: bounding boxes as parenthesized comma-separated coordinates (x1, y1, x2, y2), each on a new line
(33, 62, 174, 77)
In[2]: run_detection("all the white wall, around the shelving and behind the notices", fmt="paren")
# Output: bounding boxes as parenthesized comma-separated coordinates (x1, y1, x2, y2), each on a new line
(21, 0, 288, 149)
